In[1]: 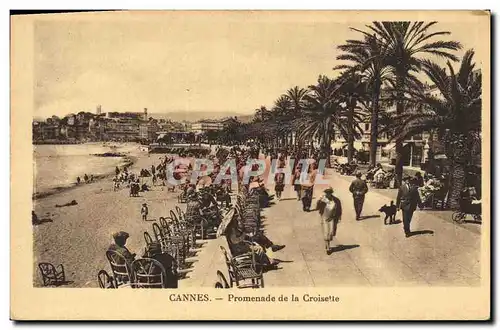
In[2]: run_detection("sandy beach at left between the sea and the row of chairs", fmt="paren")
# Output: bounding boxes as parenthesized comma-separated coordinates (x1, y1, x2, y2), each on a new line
(33, 152, 184, 287)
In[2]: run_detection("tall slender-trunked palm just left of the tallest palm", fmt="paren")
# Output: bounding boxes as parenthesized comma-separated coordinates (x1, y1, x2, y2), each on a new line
(334, 35, 389, 166)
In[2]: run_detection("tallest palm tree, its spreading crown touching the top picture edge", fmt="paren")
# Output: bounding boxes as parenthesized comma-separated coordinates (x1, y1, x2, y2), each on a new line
(354, 22, 462, 187)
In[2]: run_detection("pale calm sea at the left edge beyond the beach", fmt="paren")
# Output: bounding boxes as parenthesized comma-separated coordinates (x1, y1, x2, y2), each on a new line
(33, 143, 141, 194)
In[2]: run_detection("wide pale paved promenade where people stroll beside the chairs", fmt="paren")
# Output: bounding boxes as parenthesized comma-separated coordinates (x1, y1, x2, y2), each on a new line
(180, 171, 480, 288)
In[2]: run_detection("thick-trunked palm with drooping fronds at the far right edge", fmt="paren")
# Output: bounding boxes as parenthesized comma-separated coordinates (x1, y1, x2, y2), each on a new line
(386, 50, 481, 208)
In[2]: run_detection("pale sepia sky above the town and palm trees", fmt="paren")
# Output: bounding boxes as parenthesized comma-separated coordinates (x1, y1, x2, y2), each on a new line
(34, 12, 489, 117)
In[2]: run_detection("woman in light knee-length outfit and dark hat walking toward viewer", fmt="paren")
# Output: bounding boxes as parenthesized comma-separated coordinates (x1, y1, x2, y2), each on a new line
(317, 187, 342, 254)
